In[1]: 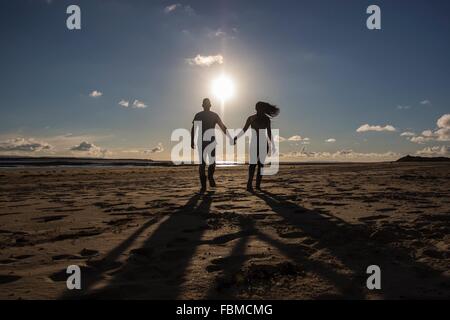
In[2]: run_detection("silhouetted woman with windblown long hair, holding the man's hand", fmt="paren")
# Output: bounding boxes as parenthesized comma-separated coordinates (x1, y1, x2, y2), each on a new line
(234, 101, 280, 191)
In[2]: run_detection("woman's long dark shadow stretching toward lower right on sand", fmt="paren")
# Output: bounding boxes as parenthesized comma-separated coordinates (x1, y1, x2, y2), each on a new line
(248, 191, 449, 299)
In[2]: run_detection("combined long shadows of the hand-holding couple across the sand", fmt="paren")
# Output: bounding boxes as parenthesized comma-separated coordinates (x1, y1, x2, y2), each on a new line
(61, 192, 449, 299)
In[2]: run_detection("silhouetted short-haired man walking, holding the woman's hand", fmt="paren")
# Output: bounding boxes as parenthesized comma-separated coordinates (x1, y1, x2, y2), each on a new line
(191, 98, 232, 193)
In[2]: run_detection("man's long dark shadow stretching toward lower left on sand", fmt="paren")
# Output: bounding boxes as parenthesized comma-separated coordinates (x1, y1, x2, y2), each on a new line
(60, 192, 213, 299)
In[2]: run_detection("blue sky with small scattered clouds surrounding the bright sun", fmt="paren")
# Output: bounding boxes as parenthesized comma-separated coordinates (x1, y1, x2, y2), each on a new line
(0, 0, 450, 161)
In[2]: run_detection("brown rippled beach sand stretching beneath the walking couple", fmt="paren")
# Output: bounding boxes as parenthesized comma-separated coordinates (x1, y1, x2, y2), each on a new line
(0, 163, 450, 299)
